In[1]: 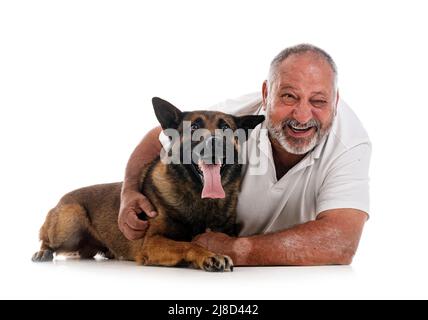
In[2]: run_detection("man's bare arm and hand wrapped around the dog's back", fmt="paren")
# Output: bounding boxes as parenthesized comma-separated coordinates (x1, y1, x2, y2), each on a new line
(118, 127, 162, 240)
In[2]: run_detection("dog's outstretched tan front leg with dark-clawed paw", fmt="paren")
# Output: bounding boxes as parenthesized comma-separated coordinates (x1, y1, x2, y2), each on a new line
(135, 235, 233, 272)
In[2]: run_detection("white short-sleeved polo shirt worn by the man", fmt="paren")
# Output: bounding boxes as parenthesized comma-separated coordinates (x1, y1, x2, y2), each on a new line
(210, 93, 371, 236)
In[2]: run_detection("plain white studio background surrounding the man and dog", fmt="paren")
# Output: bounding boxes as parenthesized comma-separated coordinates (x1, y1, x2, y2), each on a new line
(0, 0, 428, 299)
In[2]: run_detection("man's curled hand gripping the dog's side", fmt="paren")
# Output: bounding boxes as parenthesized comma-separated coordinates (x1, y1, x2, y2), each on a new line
(118, 191, 157, 240)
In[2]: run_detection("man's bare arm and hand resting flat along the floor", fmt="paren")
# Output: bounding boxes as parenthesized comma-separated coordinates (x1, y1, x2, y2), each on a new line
(194, 209, 367, 266)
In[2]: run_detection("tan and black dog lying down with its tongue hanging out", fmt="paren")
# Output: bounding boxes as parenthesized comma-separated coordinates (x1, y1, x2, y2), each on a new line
(32, 97, 264, 272)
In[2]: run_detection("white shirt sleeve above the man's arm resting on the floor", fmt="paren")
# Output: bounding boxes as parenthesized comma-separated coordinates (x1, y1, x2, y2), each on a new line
(316, 142, 371, 215)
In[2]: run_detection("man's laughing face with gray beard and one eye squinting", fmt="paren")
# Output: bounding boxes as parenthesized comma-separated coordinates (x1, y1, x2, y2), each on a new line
(263, 53, 338, 154)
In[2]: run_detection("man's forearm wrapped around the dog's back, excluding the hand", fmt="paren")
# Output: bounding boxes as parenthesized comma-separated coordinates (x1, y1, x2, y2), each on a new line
(122, 127, 162, 194)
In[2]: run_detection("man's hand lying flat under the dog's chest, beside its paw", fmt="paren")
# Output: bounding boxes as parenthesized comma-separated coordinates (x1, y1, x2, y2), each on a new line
(192, 231, 236, 261)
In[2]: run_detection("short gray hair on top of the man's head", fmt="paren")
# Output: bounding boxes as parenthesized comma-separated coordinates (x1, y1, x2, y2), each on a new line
(268, 43, 337, 89)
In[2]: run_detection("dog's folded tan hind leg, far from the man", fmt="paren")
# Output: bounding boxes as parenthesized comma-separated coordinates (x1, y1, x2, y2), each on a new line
(32, 202, 102, 262)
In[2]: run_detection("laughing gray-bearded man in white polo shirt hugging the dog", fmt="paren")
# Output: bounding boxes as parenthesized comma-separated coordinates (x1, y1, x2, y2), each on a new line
(118, 44, 371, 265)
